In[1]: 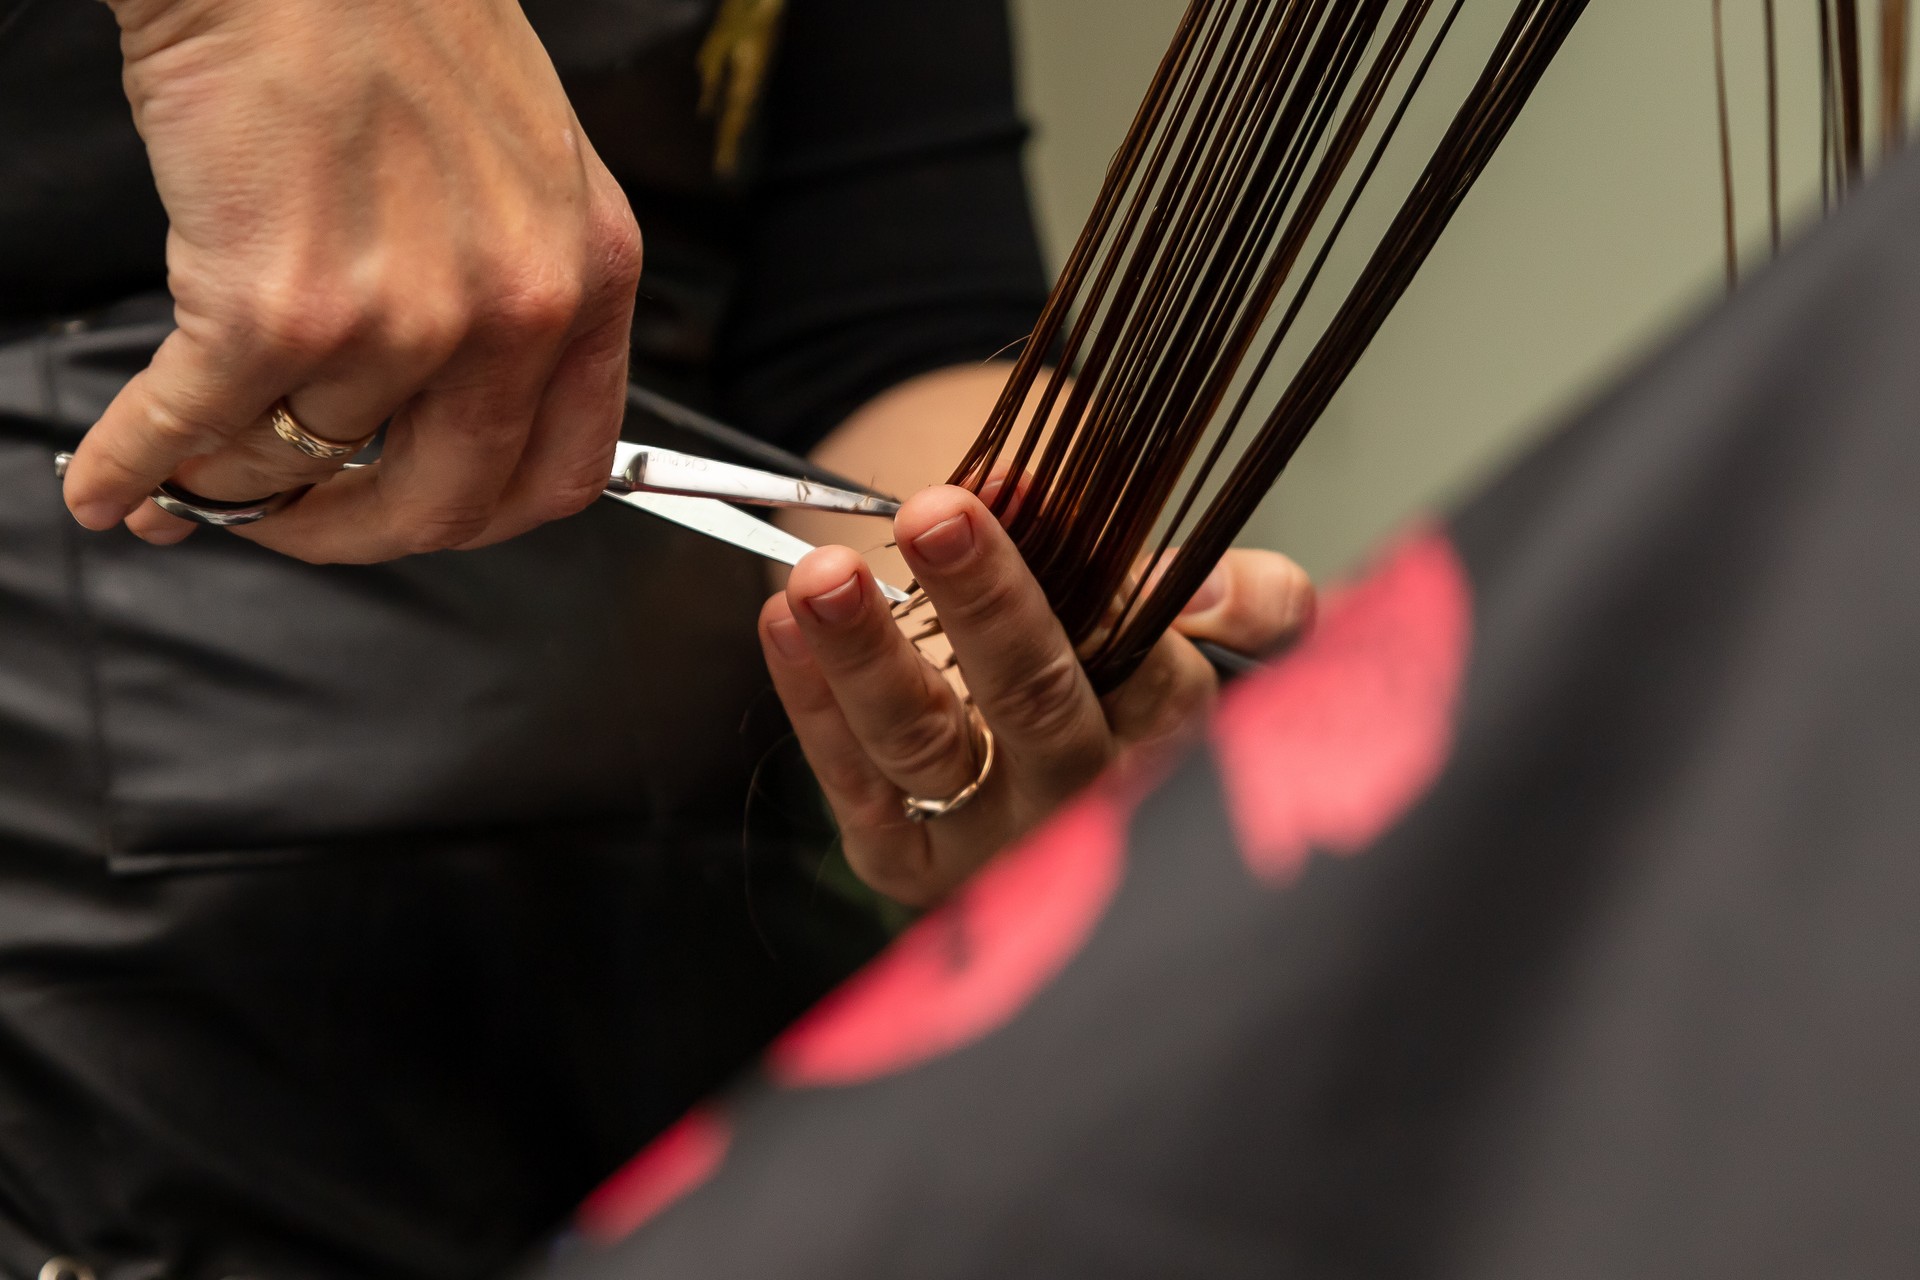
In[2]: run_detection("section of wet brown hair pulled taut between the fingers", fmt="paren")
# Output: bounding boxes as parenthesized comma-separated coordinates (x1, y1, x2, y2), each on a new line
(954, 0, 1586, 689)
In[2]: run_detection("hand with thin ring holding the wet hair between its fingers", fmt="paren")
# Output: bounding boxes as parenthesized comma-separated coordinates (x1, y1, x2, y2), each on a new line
(760, 487, 1313, 906)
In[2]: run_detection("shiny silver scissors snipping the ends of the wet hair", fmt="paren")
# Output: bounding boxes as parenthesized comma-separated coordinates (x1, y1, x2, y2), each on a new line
(54, 393, 912, 604)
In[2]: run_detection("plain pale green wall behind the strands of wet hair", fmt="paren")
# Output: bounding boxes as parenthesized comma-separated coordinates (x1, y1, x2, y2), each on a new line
(1014, 0, 1873, 578)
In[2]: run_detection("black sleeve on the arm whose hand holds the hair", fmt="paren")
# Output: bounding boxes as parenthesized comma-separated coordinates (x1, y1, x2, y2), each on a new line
(714, 0, 1046, 451)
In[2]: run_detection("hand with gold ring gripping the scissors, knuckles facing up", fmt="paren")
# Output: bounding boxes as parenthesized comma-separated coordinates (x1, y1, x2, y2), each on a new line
(67, 0, 639, 560)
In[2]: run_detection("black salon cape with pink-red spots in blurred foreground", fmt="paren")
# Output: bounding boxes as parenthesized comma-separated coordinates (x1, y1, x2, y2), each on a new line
(533, 124, 1920, 1280)
